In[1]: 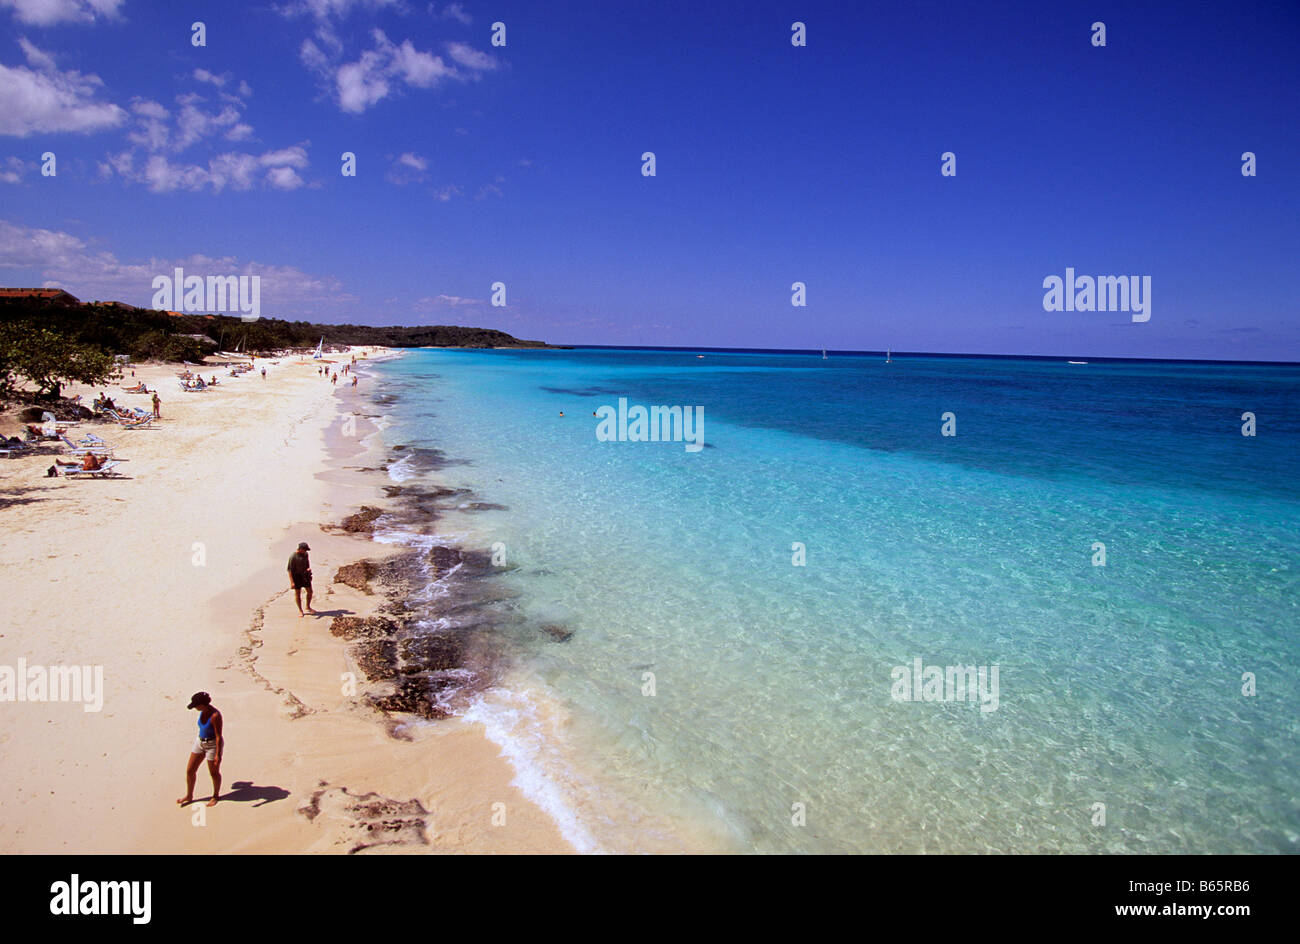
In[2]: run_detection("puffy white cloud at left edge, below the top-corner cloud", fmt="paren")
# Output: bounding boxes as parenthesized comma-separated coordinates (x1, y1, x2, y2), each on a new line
(0, 59, 126, 138)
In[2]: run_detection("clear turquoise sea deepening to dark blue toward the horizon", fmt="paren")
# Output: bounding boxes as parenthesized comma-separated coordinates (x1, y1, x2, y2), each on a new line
(376, 350, 1300, 853)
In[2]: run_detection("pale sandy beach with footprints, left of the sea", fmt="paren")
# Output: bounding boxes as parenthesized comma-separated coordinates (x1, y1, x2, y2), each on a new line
(0, 348, 572, 853)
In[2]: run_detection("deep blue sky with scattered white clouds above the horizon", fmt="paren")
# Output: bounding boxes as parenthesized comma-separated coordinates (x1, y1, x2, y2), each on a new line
(0, 0, 1300, 360)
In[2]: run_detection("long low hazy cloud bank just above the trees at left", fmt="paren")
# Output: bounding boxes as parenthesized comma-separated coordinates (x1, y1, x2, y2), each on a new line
(0, 220, 359, 320)
